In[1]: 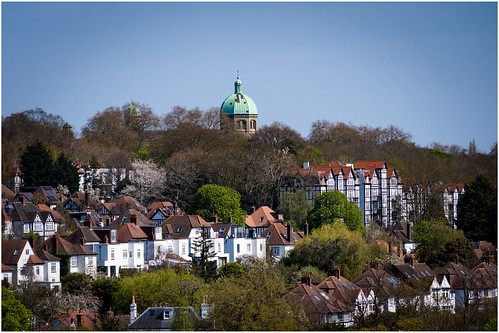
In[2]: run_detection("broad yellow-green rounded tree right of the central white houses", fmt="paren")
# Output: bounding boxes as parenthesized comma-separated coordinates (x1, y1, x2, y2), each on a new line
(282, 220, 371, 279)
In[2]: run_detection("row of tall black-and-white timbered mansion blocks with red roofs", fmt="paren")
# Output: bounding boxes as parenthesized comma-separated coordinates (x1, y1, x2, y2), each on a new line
(279, 160, 464, 228)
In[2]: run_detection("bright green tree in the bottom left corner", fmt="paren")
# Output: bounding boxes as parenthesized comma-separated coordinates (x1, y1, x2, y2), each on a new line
(2, 285, 33, 331)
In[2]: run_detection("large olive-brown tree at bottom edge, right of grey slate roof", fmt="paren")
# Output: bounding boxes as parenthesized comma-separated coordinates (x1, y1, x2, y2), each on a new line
(209, 260, 299, 331)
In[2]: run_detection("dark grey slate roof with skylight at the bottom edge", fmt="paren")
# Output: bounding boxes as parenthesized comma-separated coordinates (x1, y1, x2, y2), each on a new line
(128, 307, 200, 331)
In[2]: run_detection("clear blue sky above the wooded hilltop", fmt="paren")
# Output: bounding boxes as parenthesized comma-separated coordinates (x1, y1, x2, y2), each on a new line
(2, 2, 497, 152)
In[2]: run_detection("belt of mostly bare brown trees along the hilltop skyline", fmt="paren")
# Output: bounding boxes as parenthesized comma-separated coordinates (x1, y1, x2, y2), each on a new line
(2, 102, 497, 211)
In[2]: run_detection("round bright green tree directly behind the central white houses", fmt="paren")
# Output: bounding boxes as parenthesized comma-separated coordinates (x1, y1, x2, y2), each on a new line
(195, 184, 247, 226)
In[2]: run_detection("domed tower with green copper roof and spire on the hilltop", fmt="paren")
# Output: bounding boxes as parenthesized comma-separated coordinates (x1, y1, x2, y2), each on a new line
(220, 73, 258, 134)
